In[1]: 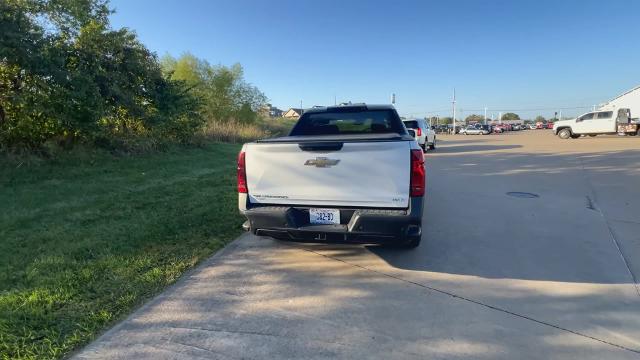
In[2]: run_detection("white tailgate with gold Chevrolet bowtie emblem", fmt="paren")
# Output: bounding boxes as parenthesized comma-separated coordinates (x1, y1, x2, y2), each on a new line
(245, 141, 411, 208)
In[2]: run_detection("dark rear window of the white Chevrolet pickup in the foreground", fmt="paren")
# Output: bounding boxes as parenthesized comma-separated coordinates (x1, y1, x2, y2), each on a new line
(290, 109, 405, 136)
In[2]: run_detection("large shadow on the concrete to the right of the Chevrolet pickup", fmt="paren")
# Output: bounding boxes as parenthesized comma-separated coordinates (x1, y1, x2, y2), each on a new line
(370, 148, 640, 284)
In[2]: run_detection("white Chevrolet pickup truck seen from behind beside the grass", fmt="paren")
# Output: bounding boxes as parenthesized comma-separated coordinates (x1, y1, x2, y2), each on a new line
(238, 104, 425, 248)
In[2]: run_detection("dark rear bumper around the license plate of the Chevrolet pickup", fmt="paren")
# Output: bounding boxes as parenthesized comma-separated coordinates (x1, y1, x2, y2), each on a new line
(244, 197, 424, 244)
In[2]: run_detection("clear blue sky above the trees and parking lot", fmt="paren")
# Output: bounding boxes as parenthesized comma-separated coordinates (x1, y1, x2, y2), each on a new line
(111, 0, 640, 117)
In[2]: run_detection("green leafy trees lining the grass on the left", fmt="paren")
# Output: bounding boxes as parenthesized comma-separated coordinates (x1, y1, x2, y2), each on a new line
(0, 0, 266, 149)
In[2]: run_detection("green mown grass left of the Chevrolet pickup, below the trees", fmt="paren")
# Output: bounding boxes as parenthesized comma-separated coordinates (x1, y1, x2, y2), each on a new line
(0, 144, 243, 359)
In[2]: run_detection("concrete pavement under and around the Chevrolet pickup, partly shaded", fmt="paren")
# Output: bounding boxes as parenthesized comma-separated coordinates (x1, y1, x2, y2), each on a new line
(78, 130, 640, 359)
